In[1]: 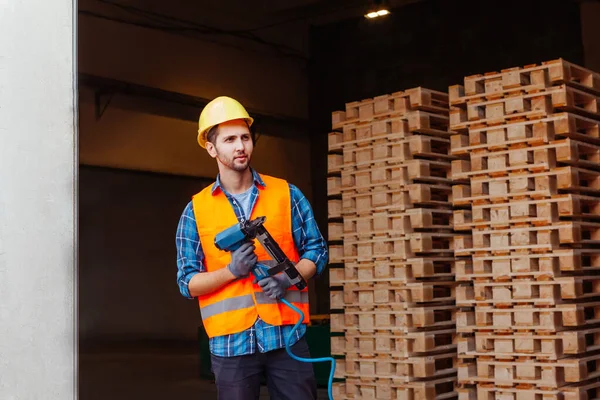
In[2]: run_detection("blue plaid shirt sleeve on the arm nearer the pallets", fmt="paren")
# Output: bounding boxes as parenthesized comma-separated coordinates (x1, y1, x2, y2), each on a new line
(289, 184, 329, 275)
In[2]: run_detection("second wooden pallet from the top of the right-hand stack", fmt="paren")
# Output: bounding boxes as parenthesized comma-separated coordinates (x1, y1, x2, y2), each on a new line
(450, 85, 600, 133)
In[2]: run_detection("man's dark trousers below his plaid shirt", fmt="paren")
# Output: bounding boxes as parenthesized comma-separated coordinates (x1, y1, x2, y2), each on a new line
(211, 338, 317, 400)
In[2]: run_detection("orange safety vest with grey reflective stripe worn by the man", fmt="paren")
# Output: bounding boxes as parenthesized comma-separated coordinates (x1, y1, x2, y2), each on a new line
(192, 175, 310, 337)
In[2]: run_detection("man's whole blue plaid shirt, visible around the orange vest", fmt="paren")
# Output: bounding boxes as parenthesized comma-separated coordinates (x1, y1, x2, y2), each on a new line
(176, 170, 328, 357)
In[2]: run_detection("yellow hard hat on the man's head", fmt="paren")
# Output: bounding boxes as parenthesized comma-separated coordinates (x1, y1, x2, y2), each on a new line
(198, 96, 254, 148)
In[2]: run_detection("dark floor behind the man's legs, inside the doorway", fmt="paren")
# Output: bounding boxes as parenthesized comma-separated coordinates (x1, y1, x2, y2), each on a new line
(79, 346, 328, 400)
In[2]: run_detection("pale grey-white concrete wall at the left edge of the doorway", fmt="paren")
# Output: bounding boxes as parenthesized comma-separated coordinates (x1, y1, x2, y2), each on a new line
(0, 0, 76, 400)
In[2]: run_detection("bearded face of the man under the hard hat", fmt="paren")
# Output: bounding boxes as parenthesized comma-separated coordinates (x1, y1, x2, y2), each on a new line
(206, 119, 254, 172)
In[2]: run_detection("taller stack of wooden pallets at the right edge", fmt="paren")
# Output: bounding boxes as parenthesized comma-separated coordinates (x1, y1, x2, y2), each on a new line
(449, 60, 600, 400)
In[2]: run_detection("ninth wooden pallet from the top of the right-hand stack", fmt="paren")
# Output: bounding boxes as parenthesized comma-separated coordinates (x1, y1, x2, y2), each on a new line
(456, 275, 600, 307)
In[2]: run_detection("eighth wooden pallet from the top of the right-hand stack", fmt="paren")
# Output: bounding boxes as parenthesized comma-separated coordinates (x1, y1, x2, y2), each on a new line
(456, 249, 600, 281)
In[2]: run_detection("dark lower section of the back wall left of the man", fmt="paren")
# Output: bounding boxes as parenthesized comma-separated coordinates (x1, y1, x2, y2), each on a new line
(79, 166, 213, 348)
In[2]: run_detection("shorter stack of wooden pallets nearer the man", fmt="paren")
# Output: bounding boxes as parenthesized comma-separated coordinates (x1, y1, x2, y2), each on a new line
(328, 88, 458, 399)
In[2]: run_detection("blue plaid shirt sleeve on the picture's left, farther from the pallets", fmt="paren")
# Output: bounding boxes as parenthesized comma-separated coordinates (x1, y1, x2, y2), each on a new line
(175, 201, 205, 299)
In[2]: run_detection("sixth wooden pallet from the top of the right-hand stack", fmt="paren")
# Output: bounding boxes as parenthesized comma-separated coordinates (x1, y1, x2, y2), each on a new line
(452, 194, 600, 231)
